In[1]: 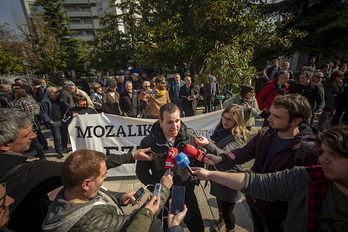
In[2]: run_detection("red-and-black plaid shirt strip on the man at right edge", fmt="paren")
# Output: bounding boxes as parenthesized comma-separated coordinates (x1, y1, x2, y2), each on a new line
(306, 165, 328, 231)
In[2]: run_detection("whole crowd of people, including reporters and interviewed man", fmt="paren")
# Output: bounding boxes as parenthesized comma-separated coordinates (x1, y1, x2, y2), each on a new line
(0, 57, 348, 232)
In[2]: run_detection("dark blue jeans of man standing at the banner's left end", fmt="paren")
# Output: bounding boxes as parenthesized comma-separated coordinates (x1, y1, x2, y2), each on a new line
(49, 121, 68, 154)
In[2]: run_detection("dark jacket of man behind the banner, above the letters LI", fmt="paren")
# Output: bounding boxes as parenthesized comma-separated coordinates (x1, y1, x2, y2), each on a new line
(120, 90, 140, 118)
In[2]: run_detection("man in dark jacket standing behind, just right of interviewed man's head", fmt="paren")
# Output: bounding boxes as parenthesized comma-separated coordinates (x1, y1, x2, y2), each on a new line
(179, 76, 199, 117)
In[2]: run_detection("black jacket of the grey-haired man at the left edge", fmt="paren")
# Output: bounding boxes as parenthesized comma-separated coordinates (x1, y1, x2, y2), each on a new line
(0, 152, 62, 231)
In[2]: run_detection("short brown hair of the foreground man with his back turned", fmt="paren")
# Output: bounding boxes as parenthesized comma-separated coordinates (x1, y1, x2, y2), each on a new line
(61, 149, 107, 189)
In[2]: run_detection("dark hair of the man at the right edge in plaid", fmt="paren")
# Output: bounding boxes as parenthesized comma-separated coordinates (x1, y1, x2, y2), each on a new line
(315, 126, 348, 158)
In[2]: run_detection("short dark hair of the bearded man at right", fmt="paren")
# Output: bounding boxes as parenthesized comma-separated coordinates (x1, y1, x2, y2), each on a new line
(273, 93, 312, 122)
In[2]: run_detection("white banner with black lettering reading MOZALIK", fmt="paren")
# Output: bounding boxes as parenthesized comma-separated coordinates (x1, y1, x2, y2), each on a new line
(69, 110, 222, 176)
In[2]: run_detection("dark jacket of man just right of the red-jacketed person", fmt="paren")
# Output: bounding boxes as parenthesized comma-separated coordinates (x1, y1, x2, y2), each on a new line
(290, 81, 325, 111)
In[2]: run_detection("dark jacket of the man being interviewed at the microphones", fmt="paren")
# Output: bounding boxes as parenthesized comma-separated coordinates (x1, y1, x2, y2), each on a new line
(135, 121, 203, 228)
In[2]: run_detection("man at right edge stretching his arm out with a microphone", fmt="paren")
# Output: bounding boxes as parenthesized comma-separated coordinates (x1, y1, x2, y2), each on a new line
(192, 126, 348, 232)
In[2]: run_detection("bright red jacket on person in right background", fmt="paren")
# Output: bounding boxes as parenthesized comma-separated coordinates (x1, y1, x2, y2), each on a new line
(256, 79, 290, 110)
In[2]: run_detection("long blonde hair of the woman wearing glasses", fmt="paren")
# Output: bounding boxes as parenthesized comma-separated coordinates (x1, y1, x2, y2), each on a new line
(215, 105, 250, 143)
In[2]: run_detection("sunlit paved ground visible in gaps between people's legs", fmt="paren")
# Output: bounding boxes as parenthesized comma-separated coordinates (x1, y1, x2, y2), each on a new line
(26, 108, 334, 232)
